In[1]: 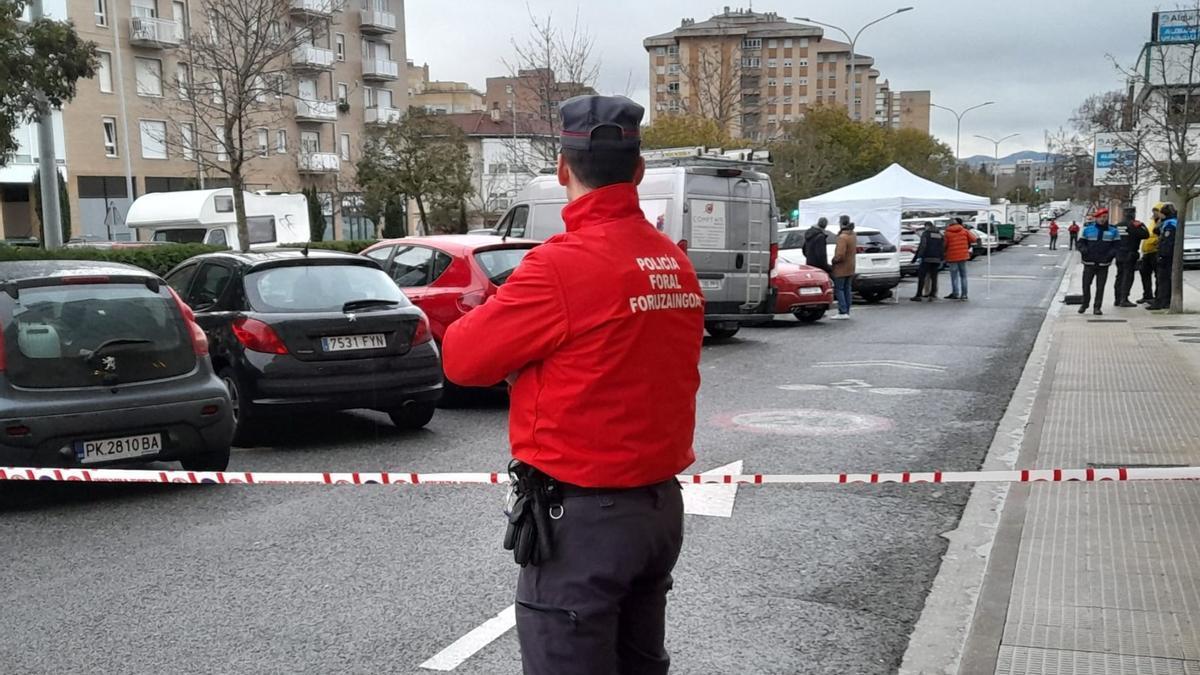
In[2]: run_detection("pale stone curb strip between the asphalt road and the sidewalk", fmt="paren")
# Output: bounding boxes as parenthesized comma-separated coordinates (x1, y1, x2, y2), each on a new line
(899, 258, 1074, 675)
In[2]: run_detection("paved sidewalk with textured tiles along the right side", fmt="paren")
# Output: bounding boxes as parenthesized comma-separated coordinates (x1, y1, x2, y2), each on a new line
(902, 263, 1200, 675)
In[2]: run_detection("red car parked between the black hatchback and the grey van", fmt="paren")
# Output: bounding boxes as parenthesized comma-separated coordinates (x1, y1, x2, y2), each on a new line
(362, 234, 539, 345)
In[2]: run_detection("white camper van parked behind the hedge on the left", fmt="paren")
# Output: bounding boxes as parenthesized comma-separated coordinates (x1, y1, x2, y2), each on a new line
(125, 187, 311, 251)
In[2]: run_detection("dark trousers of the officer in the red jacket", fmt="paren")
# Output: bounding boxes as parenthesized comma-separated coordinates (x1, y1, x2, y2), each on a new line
(516, 479, 683, 675)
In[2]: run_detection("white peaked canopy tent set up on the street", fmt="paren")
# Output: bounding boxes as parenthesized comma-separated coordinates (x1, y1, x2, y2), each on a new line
(797, 165, 991, 243)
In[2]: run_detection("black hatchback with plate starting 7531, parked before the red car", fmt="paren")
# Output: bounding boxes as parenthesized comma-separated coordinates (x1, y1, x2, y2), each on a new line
(166, 250, 442, 443)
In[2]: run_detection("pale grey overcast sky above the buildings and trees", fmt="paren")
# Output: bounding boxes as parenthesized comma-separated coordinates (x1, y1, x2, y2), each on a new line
(406, 0, 1156, 156)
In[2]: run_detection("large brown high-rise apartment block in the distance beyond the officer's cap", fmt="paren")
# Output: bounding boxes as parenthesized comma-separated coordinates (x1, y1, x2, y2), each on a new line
(642, 7, 880, 139)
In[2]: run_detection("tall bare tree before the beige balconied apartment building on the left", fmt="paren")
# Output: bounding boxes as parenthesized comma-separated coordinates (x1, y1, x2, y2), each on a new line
(153, 0, 340, 251)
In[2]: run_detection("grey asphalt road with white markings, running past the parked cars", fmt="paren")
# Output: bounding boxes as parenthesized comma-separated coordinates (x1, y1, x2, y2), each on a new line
(0, 234, 1067, 675)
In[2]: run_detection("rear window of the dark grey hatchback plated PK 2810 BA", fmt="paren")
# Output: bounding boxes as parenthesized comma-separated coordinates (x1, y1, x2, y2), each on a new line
(5, 283, 196, 388)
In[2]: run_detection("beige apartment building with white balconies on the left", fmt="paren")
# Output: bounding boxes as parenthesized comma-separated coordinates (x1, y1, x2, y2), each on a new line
(0, 0, 408, 240)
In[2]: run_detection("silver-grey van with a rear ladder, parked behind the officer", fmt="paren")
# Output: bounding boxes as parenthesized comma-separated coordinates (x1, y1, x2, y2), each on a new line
(496, 166, 779, 338)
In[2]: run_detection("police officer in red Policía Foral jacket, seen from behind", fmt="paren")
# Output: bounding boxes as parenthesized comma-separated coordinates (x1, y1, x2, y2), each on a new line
(443, 96, 704, 675)
